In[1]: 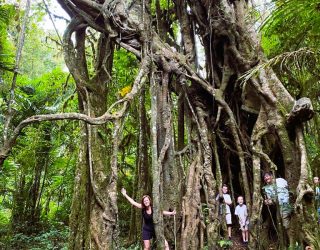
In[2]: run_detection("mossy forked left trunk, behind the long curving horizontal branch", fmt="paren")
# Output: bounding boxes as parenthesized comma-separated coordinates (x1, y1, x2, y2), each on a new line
(64, 17, 121, 249)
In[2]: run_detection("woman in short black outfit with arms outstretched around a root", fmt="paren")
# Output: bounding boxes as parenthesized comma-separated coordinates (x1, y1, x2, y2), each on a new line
(121, 188, 176, 250)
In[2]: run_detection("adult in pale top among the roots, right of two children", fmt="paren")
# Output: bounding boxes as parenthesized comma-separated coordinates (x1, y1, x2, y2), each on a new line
(262, 172, 292, 229)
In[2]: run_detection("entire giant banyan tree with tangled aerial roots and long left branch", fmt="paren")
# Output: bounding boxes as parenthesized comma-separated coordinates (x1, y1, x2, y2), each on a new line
(1, 0, 319, 249)
